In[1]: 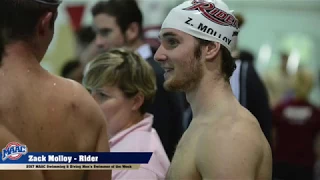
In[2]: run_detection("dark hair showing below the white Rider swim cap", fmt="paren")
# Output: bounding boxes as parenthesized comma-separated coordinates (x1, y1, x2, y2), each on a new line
(194, 38, 236, 82)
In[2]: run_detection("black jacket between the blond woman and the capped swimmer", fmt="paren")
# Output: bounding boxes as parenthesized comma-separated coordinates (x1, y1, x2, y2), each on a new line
(147, 54, 183, 160)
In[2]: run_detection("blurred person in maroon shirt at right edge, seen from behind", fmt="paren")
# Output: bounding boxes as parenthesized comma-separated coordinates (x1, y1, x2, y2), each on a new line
(273, 70, 320, 180)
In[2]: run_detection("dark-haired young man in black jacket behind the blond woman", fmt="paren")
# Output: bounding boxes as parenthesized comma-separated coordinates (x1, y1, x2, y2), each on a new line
(92, 0, 182, 159)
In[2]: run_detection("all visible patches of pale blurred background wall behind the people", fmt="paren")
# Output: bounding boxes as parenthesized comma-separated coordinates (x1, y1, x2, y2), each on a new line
(42, 0, 320, 105)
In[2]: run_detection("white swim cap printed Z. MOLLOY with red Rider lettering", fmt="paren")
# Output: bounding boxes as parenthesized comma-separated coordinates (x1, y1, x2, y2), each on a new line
(161, 0, 239, 52)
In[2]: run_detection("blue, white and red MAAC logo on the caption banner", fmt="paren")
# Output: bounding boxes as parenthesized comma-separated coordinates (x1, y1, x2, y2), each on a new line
(2, 142, 28, 161)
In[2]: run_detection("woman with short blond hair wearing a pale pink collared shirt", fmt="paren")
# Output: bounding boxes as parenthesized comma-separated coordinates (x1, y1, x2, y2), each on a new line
(84, 49, 170, 179)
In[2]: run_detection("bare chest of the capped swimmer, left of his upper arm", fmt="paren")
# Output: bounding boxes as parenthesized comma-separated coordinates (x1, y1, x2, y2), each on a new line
(167, 130, 201, 180)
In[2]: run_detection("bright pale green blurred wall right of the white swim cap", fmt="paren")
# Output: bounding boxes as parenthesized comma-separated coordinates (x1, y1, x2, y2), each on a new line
(226, 0, 320, 105)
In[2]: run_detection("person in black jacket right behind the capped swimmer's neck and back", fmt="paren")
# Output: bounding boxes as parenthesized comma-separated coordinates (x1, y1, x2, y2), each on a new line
(230, 14, 272, 143)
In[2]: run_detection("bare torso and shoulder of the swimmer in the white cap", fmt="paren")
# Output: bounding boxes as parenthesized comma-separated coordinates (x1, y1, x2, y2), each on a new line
(168, 100, 272, 180)
